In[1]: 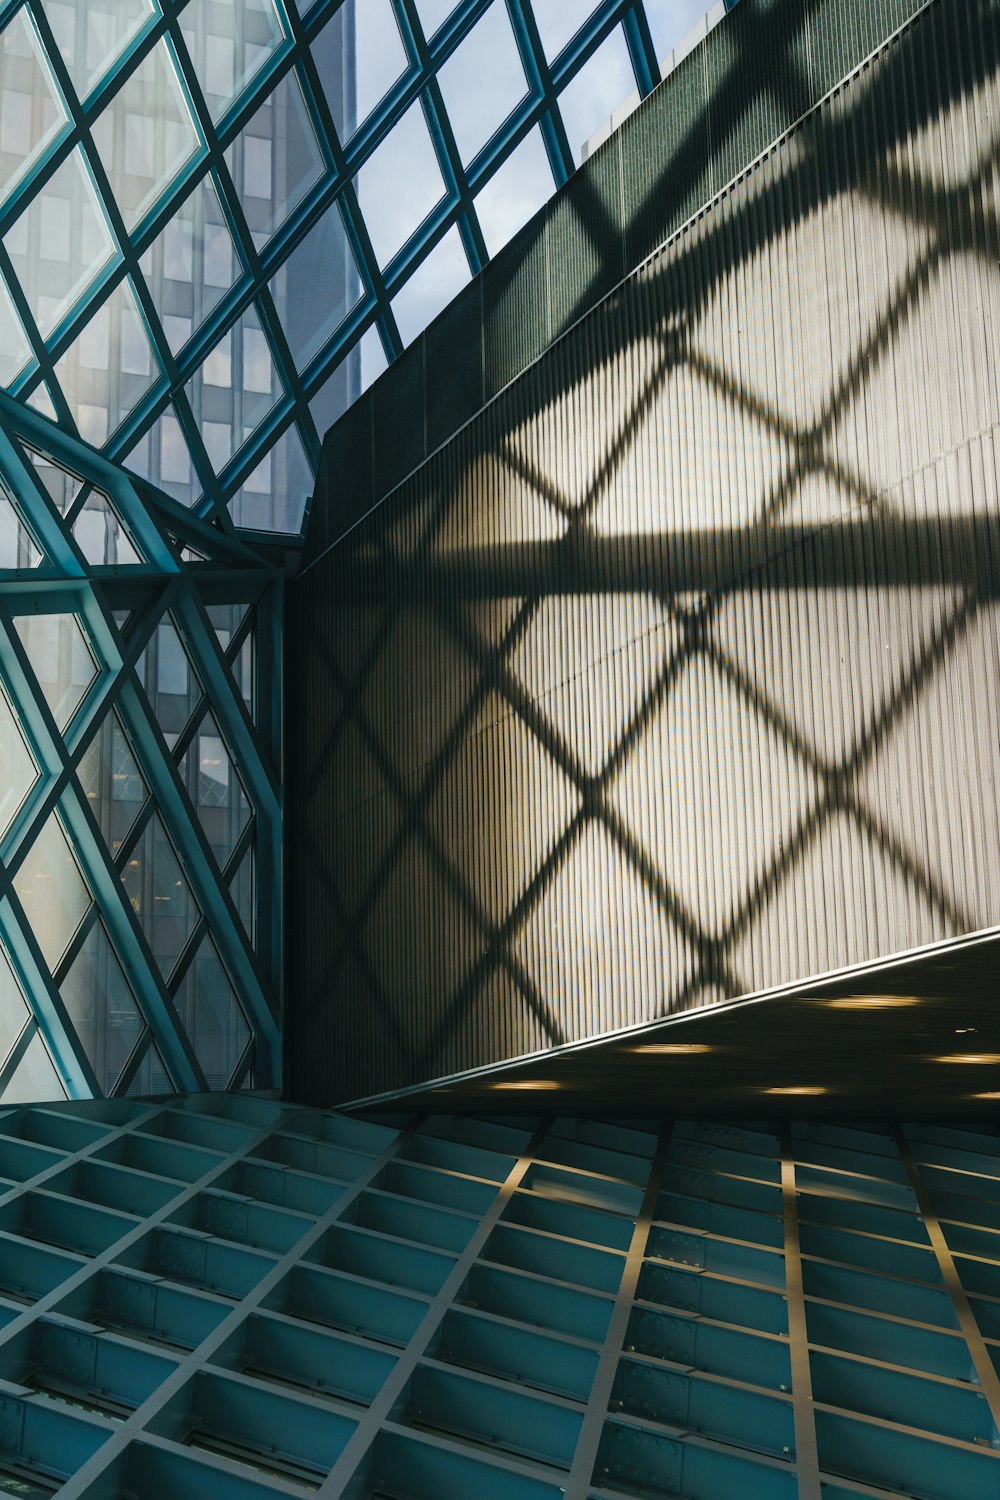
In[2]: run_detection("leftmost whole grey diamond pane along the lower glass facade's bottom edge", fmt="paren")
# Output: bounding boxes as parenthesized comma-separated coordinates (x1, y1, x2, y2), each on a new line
(60, 921, 142, 1095)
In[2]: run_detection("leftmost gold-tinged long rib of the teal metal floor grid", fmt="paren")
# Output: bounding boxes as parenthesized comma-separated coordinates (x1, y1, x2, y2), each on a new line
(316, 1122, 550, 1500)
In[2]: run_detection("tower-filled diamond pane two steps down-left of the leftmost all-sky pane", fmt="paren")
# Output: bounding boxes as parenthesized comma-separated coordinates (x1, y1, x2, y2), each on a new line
(186, 295, 282, 473)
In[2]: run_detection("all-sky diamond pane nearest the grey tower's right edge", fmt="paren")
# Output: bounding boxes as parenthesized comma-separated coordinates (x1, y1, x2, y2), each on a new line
(357, 102, 444, 266)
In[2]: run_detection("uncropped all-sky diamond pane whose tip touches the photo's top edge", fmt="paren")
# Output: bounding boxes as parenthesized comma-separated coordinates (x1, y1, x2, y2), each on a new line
(438, 0, 528, 165)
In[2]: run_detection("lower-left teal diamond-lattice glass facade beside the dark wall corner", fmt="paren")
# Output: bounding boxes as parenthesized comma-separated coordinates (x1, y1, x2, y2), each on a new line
(0, 393, 280, 1101)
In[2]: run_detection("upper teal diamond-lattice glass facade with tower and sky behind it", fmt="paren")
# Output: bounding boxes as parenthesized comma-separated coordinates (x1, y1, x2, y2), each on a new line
(0, 0, 721, 534)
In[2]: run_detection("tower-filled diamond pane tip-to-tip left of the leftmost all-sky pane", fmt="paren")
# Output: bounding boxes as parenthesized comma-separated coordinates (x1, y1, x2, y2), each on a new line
(225, 71, 324, 249)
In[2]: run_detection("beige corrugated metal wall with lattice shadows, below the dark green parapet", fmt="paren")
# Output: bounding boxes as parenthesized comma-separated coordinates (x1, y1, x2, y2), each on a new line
(288, 0, 1000, 1100)
